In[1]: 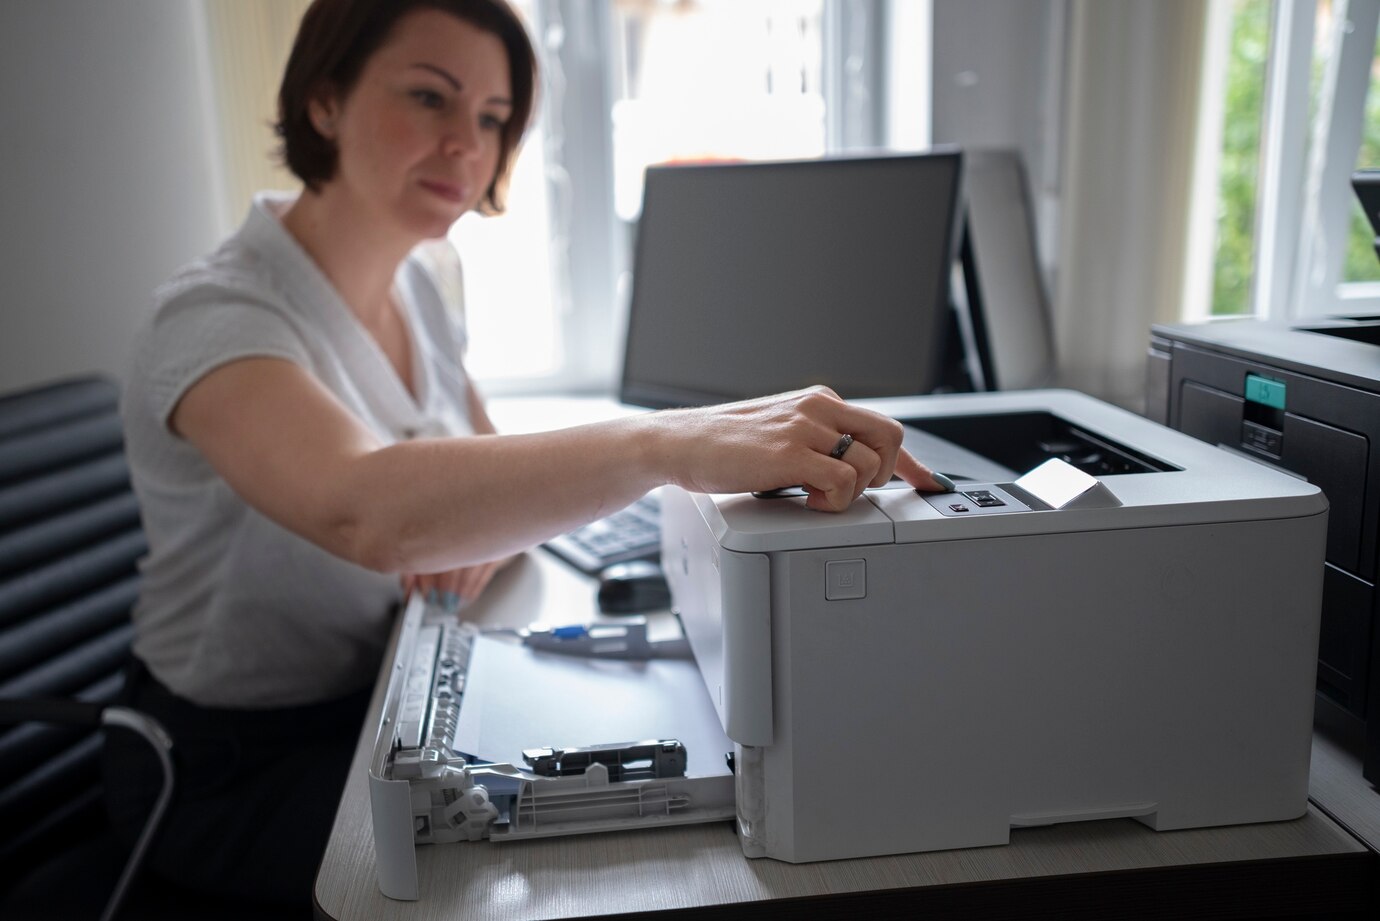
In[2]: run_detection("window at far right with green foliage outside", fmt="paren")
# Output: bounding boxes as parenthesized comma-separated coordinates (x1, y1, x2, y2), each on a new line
(1203, 0, 1380, 319)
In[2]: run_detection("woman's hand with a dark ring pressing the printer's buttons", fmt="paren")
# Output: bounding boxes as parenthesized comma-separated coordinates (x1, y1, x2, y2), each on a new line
(651, 387, 952, 511)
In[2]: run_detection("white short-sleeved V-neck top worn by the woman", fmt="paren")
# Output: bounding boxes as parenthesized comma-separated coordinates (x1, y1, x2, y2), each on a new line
(121, 193, 473, 708)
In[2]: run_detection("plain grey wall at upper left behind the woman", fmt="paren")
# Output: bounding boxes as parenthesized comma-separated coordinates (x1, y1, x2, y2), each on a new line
(0, 0, 224, 392)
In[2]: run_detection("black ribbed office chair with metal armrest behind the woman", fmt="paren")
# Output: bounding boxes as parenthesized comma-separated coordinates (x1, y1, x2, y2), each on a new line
(0, 377, 173, 918)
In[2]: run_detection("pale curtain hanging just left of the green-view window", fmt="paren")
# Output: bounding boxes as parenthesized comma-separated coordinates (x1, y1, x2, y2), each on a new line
(1053, 0, 1208, 410)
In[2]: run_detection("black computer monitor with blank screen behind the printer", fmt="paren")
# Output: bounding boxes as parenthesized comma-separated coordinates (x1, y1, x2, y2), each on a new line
(620, 151, 963, 407)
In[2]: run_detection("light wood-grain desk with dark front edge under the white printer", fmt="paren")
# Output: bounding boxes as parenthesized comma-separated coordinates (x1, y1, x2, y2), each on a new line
(315, 397, 1380, 921)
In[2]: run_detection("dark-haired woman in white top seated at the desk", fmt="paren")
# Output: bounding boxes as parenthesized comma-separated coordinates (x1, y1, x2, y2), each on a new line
(110, 0, 941, 902)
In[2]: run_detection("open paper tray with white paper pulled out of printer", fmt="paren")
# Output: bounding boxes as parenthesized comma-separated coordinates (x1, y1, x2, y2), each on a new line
(368, 598, 736, 899)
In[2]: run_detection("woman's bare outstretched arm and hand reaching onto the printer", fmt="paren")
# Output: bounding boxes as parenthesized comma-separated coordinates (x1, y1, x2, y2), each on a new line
(170, 358, 938, 573)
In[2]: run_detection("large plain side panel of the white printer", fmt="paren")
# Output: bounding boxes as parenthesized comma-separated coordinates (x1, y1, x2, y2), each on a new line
(763, 512, 1326, 862)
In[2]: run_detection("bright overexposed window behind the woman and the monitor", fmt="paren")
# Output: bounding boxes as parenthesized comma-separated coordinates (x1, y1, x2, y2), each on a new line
(451, 0, 910, 394)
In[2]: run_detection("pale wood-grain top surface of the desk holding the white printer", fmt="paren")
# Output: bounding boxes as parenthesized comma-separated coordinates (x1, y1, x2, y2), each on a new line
(316, 400, 1380, 921)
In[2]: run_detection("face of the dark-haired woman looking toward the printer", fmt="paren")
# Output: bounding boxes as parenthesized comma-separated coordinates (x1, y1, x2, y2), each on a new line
(311, 10, 512, 239)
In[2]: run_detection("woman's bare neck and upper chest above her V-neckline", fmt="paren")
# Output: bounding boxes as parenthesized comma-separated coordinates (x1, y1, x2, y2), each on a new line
(282, 188, 417, 329)
